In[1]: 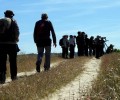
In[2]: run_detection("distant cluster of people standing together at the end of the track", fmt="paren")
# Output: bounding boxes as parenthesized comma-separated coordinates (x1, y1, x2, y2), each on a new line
(59, 31, 113, 59)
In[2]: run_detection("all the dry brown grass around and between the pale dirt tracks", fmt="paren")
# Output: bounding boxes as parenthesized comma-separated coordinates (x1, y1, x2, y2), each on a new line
(0, 53, 120, 100)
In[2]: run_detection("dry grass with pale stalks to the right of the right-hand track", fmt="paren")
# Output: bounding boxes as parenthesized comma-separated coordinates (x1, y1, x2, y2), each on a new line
(90, 53, 120, 100)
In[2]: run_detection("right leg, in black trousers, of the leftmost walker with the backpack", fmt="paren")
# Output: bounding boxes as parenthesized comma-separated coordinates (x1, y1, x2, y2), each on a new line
(8, 44, 17, 80)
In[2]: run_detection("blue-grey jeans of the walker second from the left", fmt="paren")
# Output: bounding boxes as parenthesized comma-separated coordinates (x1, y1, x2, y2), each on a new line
(36, 46, 51, 72)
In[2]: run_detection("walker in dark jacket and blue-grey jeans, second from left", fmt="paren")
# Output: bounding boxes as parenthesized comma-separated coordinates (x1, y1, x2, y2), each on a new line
(33, 13, 57, 72)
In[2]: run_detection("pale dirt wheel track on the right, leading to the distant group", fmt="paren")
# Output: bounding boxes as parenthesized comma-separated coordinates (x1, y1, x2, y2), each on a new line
(43, 58, 101, 100)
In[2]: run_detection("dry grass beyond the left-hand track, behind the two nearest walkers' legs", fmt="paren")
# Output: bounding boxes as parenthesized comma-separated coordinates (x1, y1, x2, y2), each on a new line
(7, 54, 61, 77)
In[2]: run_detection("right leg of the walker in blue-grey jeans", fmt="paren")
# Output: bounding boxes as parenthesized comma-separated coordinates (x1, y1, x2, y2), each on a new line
(44, 46, 51, 71)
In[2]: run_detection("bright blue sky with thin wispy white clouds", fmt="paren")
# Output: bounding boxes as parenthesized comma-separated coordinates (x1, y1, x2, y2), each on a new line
(0, 0, 120, 53)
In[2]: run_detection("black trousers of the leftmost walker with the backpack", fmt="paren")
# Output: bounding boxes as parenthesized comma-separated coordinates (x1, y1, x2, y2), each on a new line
(0, 44, 17, 81)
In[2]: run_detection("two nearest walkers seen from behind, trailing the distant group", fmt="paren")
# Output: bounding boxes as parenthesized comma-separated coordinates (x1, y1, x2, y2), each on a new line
(0, 10, 57, 84)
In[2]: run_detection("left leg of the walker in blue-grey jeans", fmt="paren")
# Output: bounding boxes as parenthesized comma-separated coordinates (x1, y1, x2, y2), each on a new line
(36, 47, 44, 72)
